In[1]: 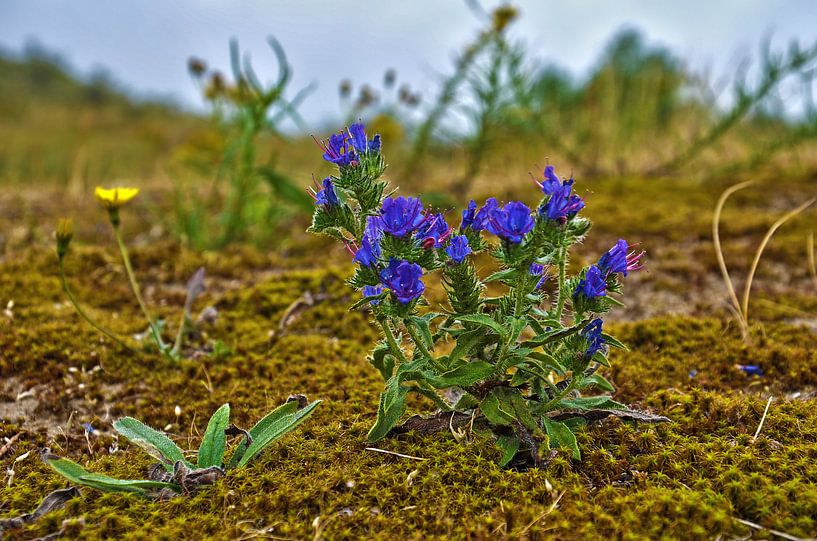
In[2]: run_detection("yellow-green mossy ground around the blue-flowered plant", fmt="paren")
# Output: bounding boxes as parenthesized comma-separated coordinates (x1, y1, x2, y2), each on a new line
(0, 174, 817, 539)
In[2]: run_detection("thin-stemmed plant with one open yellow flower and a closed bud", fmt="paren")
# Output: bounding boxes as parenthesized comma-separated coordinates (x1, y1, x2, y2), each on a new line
(56, 187, 204, 360)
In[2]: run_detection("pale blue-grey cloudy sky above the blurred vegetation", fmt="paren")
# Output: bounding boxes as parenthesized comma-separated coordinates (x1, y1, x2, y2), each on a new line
(0, 0, 817, 124)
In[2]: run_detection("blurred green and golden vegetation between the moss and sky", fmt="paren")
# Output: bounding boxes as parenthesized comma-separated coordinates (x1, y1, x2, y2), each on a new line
(0, 2, 817, 253)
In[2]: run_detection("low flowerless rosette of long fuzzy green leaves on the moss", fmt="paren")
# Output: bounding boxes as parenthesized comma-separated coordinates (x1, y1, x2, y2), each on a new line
(42, 395, 321, 498)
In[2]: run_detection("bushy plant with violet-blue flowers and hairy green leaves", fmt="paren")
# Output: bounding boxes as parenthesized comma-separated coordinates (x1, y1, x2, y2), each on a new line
(310, 124, 664, 464)
